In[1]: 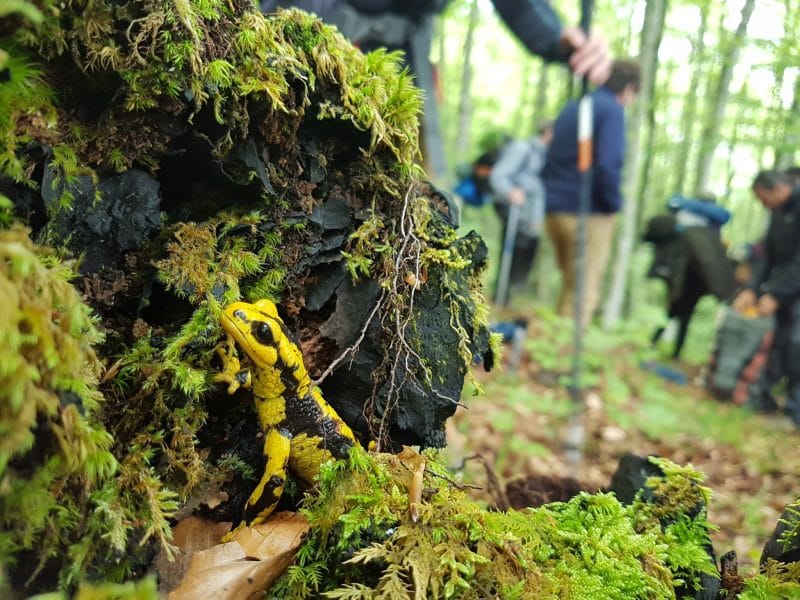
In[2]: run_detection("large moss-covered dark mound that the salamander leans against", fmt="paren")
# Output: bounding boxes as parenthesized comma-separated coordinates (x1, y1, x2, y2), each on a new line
(0, 0, 489, 591)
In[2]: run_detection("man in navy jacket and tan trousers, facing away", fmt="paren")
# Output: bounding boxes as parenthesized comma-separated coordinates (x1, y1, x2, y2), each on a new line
(544, 60, 639, 325)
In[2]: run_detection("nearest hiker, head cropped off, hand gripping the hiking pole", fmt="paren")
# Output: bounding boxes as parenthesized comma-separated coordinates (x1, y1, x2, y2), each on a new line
(261, 0, 611, 181)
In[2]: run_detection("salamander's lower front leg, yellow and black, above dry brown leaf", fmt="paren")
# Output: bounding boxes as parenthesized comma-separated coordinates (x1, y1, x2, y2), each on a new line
(223, 429, 292, 541)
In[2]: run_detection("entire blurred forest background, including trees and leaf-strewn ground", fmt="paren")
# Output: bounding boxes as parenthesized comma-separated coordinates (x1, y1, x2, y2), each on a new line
(431, 0, 800, 565)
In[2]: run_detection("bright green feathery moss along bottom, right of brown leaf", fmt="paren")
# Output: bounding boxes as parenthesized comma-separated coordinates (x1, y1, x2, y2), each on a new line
(270, 450, 716, 600)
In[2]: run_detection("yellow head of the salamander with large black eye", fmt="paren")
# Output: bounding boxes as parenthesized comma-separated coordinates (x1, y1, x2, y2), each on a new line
(221, 300, 288, 367)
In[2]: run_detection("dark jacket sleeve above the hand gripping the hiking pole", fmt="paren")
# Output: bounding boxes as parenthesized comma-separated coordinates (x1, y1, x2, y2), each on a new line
(493, 0, 569, 62)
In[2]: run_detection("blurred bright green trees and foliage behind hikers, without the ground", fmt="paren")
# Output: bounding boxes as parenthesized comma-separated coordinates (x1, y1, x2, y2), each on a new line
(432, 0, 800, 326)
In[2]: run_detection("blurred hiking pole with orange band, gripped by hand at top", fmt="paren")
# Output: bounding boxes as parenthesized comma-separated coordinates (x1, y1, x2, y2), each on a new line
(565, 0, 593, 466)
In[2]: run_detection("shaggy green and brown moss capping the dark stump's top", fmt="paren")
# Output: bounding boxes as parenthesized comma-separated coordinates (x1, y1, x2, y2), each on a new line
(0, 0, 421, 195)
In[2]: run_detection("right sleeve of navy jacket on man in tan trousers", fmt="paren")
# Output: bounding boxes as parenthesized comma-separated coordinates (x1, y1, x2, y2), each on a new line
(592, 95, 625, 213)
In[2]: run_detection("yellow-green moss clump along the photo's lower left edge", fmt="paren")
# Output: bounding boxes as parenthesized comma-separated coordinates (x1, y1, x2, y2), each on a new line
(0, 227, 175, 589)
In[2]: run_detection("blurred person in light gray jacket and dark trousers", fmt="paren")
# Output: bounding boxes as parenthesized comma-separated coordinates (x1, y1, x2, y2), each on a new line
(489, 122, 553, 305)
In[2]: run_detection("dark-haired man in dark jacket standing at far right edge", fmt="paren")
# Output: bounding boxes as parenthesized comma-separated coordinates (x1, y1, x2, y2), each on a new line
(733, 171, 800, 427)
